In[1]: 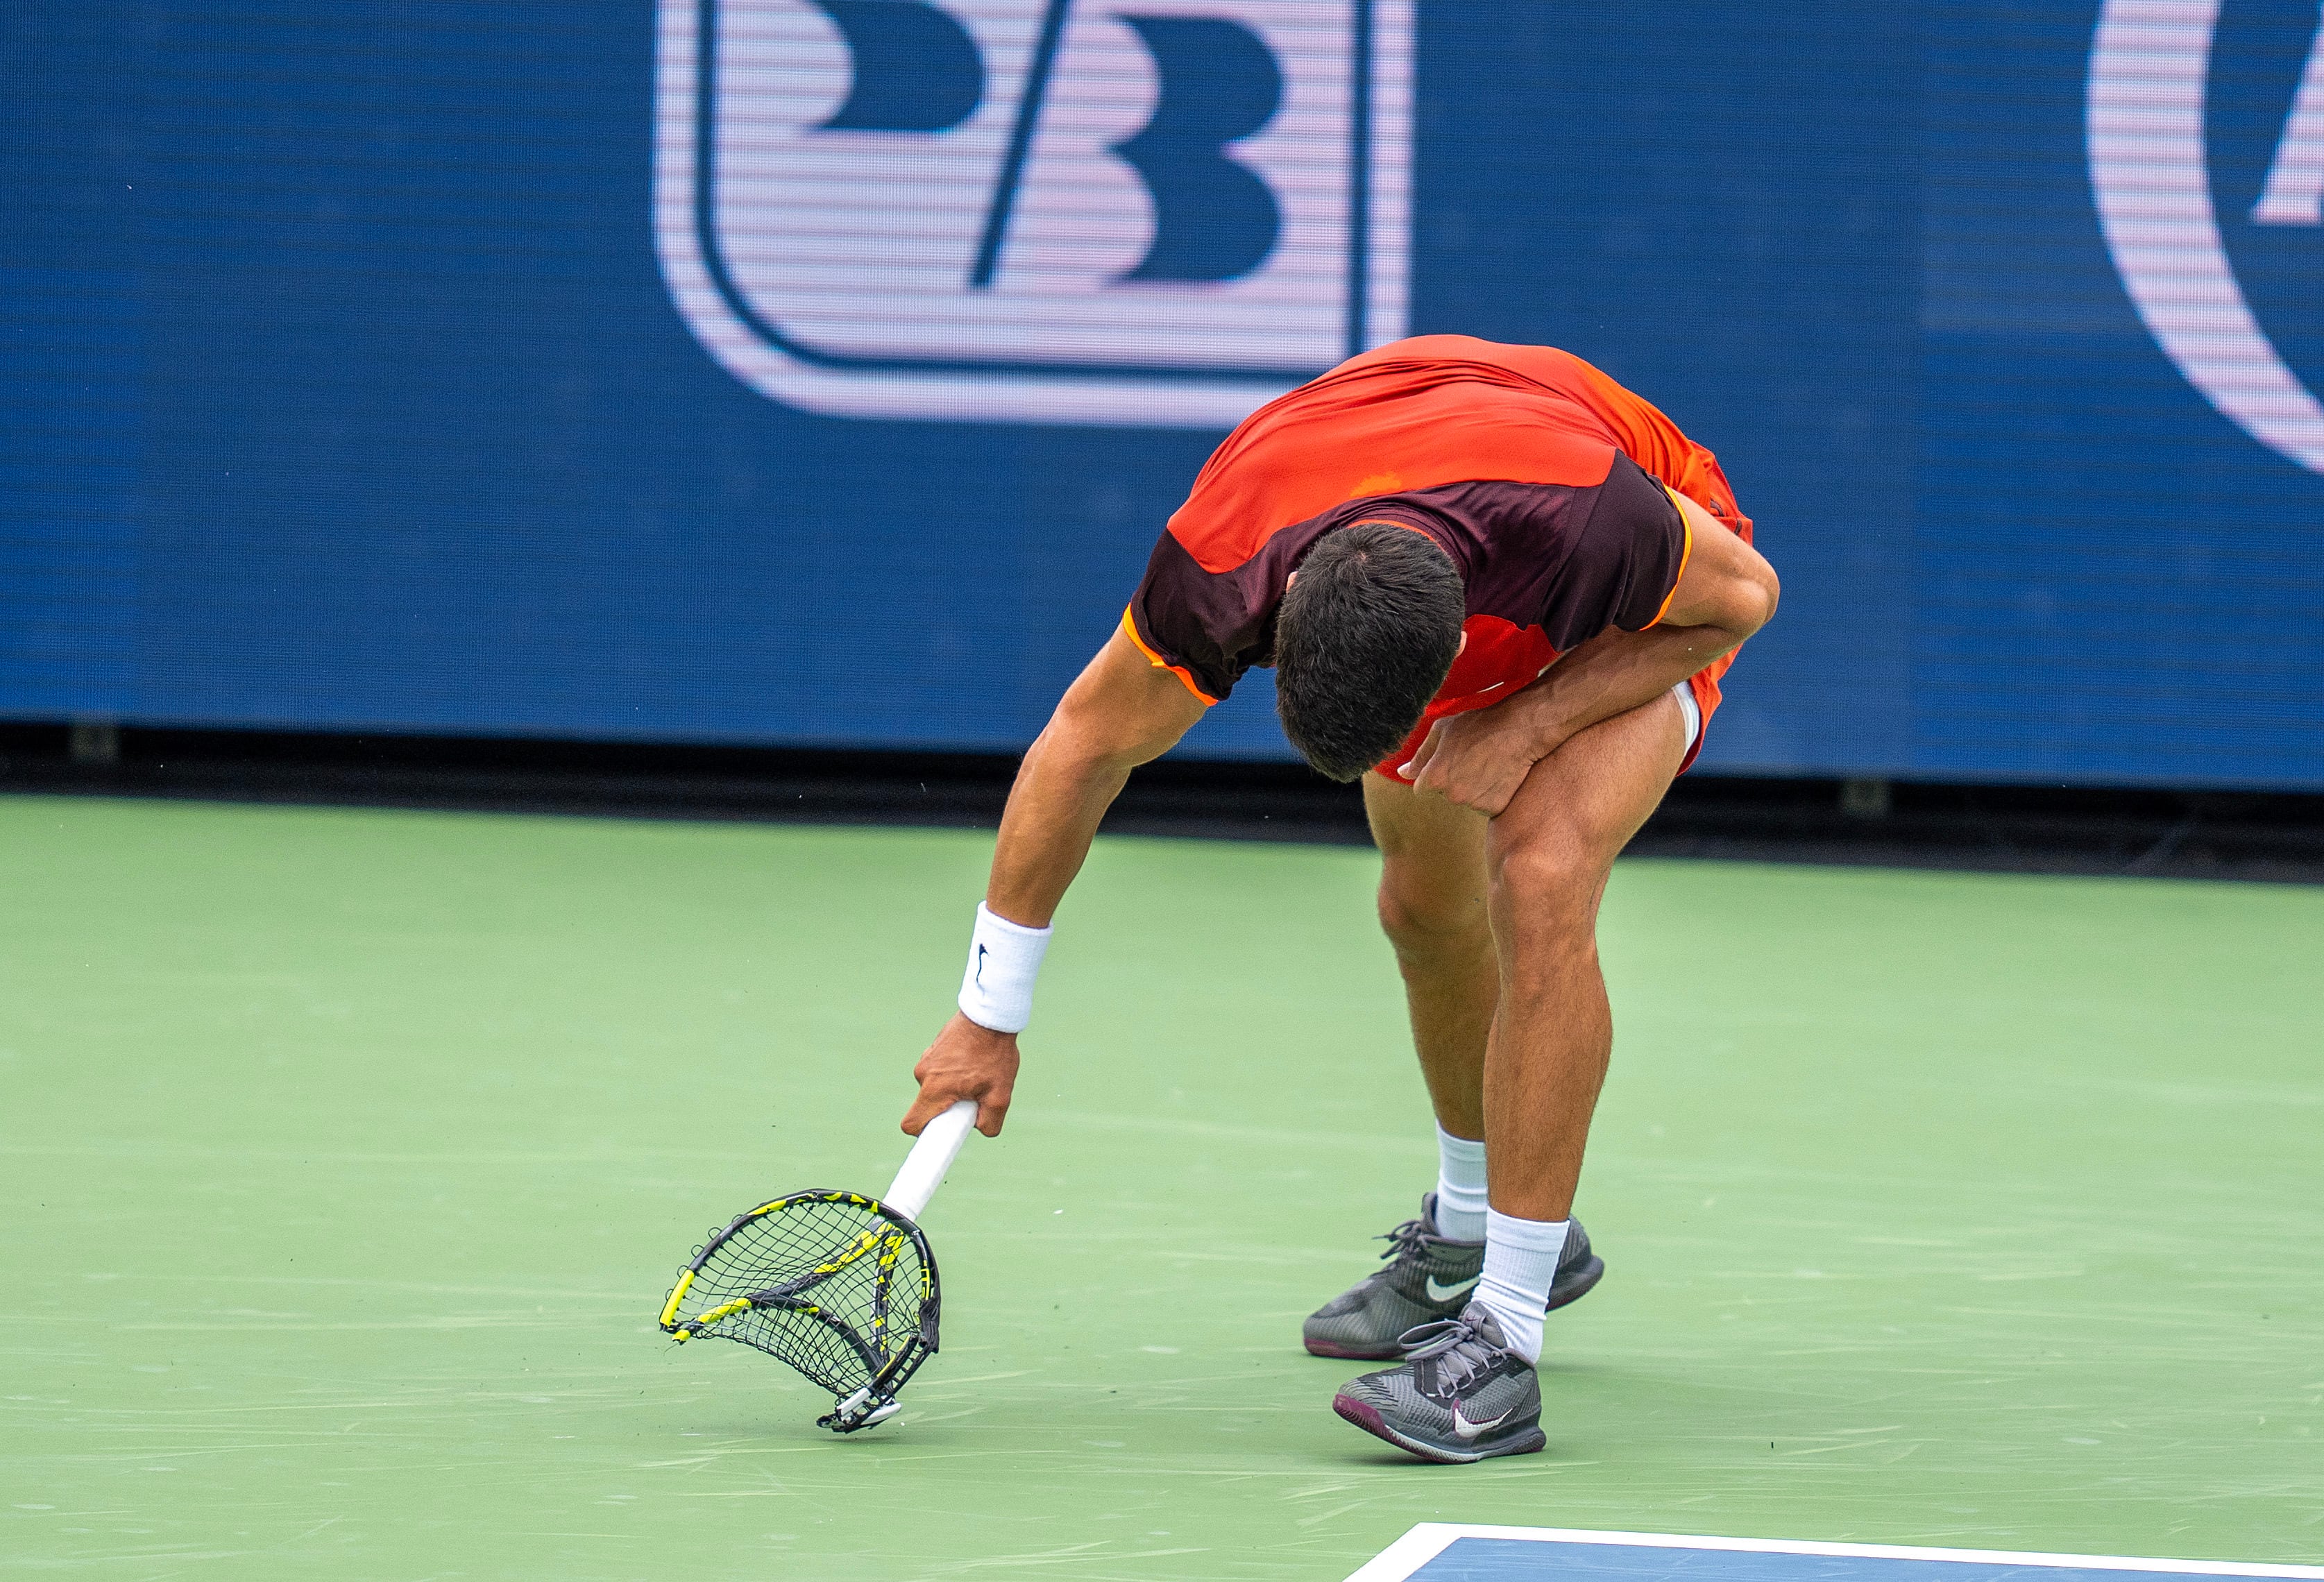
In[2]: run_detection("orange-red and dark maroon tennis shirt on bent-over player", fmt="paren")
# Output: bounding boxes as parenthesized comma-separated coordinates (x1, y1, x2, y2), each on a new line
(1123, 334, 1750, 774)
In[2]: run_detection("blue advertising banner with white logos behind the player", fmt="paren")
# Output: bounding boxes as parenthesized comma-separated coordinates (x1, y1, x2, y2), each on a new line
(0, 0, 2324, 790)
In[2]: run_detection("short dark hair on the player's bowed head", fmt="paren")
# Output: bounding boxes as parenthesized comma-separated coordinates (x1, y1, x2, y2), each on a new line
(1276, 522, 1466, 781)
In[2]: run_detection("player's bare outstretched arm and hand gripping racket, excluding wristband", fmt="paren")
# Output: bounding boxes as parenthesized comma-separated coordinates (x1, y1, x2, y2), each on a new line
(904, 627, 1206, 1136)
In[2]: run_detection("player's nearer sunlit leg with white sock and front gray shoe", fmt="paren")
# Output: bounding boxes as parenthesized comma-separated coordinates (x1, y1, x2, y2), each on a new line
(1332, 697, 1692, 1461)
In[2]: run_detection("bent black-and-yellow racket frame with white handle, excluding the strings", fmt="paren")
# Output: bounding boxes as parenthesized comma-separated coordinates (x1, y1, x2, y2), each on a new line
(660, 1099, 976, 1434)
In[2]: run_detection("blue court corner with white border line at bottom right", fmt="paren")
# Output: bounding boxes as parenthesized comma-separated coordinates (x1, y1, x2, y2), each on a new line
(1348, 1522, 2324, 1582)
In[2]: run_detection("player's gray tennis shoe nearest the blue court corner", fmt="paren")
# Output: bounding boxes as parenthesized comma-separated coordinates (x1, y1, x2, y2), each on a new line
(1332, 1303, 1550, 1461)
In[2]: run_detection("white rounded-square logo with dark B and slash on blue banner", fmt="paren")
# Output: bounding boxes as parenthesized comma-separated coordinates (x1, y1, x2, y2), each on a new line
(655, 0, 1411, 427)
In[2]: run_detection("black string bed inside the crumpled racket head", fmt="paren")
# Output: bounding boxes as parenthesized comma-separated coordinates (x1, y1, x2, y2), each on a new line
(677, 1194, 937, 1396)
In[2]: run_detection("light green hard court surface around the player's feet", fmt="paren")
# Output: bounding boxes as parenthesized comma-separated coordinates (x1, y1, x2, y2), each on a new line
(0, 797, 2324, 1582)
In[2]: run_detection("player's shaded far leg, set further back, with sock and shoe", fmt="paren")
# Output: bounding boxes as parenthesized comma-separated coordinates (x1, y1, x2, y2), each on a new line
(1301, 774, 1606, 1359)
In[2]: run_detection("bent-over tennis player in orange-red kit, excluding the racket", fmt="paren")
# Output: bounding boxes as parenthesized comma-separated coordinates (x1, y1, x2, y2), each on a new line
(904, 334, 1776, 1461)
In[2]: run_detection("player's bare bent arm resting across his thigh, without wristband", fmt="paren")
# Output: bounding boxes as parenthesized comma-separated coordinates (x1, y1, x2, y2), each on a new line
(1413, 497, 1780, 815)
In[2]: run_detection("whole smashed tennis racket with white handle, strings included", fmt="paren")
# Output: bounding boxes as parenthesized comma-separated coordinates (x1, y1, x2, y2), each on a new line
(662, 1099, 976, 1434)
